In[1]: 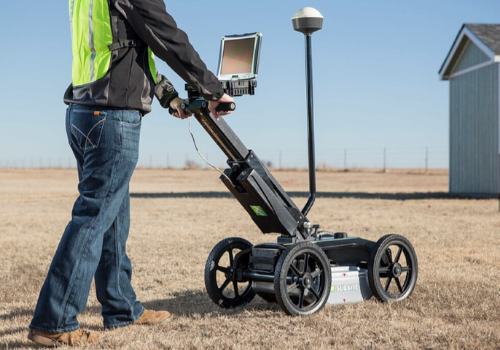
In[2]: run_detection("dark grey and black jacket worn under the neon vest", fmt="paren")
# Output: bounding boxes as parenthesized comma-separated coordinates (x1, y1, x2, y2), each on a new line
(64, 0, 223, 114)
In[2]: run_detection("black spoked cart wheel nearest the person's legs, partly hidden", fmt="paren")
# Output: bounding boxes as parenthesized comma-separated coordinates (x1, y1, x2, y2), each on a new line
(205, 237, 255, 308)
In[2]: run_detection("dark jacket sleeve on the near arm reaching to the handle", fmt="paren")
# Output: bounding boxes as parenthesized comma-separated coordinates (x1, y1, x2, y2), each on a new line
(111, 0, 224, 101)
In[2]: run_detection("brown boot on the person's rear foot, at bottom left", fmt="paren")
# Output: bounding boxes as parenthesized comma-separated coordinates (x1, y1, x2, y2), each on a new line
(28, 329, 101, 346)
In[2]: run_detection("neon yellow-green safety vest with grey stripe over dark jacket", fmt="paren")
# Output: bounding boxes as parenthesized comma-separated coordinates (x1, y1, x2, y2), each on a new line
(69, 0, 156, 86)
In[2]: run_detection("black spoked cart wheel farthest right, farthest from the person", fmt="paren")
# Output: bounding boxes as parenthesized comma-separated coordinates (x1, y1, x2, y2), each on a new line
(368, 234, 418, 302)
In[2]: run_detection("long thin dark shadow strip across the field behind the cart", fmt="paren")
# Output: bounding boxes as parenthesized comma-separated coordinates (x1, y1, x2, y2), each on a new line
(130, 191, 498, 201)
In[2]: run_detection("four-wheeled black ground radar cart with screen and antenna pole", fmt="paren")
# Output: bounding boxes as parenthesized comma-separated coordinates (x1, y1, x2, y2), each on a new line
(172, 7, 418, 316)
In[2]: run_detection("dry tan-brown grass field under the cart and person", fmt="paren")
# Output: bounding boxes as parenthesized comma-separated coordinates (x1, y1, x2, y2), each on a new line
(0, 169, 500, 349)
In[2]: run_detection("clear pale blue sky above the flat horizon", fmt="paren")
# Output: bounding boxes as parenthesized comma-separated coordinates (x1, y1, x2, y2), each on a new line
(0, 0, 500, 168)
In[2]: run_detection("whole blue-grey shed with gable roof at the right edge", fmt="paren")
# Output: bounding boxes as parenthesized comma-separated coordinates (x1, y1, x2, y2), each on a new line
(439, 24, 500, 195)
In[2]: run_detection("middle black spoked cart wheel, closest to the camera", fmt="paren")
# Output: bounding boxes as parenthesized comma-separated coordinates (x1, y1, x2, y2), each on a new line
(274, 242, 331, 316)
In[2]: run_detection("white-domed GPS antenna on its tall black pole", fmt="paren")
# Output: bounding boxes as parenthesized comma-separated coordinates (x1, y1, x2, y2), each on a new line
(292, 7, 323, 216)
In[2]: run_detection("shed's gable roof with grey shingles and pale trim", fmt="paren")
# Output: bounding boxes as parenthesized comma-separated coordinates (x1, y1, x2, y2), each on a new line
(439, 23, 500, 80)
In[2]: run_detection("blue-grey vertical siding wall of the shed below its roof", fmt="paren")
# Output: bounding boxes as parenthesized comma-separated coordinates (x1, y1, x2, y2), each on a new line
(450, 63, 500, 194)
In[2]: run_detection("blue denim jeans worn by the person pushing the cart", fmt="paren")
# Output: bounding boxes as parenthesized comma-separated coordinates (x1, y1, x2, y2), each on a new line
(30, 105, 144, 333)
